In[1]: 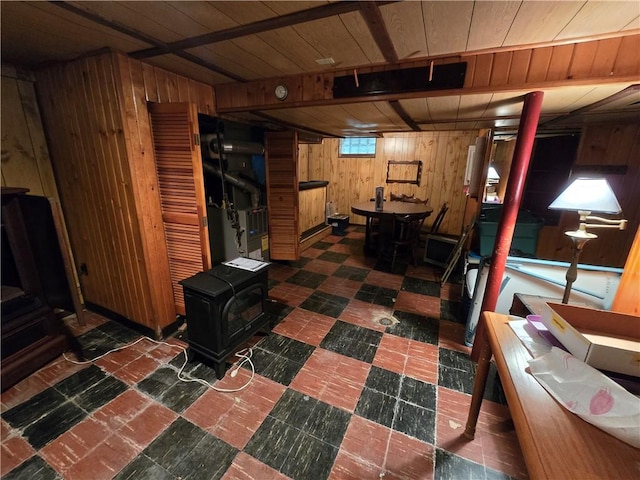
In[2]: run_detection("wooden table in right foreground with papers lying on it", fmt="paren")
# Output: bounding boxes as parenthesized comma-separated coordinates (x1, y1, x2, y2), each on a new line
(465, 312, 640, 480)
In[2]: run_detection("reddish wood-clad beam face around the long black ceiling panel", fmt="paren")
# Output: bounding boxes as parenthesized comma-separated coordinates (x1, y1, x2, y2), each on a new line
(215, 34, 640, 114)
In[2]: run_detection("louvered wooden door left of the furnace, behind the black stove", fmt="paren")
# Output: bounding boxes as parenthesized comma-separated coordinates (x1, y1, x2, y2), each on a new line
(148, 103, 211, 315)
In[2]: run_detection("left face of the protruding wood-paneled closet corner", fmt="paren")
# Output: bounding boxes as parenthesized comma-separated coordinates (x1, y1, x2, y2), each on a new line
(37, 55, 155, 325)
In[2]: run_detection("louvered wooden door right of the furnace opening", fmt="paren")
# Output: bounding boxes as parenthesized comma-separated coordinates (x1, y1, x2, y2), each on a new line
(265, 132, 300, 260)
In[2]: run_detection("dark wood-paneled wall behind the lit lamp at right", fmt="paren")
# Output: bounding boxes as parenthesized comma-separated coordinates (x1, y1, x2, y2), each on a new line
(537, 122, 640, 268)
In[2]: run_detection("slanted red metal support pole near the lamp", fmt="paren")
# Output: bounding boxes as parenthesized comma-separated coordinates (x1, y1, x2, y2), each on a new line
(471, 92, 544, 362)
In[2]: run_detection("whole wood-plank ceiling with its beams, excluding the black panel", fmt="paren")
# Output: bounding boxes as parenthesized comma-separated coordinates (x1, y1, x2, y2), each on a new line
(0, 0, 640, 136)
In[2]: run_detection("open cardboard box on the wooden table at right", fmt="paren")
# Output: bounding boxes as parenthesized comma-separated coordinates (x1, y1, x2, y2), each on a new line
(542, 303, 640, 377)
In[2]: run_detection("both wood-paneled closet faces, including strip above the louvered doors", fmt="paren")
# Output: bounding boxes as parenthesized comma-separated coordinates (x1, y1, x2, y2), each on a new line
(36, 49, 214, 336)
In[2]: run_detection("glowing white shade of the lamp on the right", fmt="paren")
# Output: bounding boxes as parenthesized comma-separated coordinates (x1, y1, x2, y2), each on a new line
(549, 178, 622, 213)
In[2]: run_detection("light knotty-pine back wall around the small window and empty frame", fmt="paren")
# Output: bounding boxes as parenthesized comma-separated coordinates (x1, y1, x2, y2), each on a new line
(301, 130, 478, 234)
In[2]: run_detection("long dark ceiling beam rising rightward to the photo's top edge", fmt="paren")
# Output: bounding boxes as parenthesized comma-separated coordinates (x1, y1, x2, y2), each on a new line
(129, 0, 397, 60)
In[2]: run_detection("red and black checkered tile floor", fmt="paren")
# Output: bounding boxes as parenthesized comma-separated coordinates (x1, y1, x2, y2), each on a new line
(0, 227, 527, 480)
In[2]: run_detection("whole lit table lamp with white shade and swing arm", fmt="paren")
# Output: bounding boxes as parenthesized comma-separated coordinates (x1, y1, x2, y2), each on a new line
(549, 178, 627, 303)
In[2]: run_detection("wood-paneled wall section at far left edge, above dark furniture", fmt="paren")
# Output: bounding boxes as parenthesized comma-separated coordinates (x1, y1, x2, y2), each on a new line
(1, 64, 59, 200)
